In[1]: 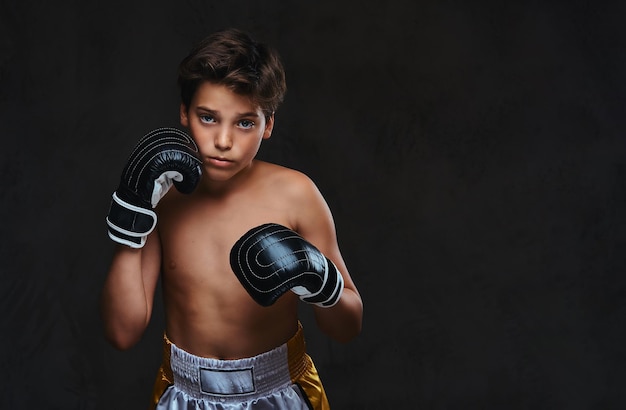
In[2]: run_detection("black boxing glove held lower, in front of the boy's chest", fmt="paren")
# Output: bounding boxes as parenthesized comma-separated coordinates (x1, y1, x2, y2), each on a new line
(230, 223, 343, 307)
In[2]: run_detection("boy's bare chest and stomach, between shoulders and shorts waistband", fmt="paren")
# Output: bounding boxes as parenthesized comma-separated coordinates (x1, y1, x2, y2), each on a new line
(158, 187, 296, 357)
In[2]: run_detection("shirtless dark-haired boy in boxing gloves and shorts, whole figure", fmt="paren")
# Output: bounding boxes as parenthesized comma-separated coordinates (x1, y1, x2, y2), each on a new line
(102, 29, 363, 409)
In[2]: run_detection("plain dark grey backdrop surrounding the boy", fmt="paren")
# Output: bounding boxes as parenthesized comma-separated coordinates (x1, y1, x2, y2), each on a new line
(0, 0, 626, 409)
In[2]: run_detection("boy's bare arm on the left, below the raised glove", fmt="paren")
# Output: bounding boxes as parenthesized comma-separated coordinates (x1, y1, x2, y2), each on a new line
(101, 230, 161, 350)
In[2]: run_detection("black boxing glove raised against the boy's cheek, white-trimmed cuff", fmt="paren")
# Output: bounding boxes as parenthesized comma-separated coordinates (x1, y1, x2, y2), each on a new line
(106, 128, 202, 248)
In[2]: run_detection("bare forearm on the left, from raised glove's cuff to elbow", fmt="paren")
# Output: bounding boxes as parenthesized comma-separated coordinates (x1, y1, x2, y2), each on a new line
(102, 246, 151, 349)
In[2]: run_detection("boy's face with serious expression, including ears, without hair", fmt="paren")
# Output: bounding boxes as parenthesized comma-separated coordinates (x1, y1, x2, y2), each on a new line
(180, 81, 274, 181)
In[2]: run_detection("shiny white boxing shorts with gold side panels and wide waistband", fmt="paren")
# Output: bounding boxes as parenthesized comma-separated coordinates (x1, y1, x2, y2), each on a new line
(151, 326, 330, 410)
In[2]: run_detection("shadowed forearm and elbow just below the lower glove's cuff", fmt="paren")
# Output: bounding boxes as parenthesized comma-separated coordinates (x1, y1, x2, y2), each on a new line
(314, 288, 363, 343)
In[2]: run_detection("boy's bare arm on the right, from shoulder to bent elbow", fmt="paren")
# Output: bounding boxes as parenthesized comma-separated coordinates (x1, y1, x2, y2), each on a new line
(294, 178, 363, 343)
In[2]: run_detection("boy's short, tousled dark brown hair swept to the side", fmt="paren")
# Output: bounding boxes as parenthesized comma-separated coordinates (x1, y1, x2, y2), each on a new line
(178, 28, 287, 117)
